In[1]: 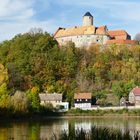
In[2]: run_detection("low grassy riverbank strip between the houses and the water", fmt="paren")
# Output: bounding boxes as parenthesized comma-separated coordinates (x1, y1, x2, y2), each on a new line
(0, 109, 140, 121)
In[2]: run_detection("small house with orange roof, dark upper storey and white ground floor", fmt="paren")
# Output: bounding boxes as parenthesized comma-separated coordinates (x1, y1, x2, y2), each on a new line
(74, 93, 92, 109)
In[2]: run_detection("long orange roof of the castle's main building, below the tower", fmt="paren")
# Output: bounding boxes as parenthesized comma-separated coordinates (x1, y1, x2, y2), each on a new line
(54, 25, 107, 38)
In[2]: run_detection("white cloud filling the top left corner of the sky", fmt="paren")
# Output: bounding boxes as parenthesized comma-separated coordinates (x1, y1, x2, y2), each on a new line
(0, 0, 35, 20)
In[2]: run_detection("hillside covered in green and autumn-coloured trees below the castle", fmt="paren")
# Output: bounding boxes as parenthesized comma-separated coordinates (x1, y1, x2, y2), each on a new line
(0, 32, 140, 105)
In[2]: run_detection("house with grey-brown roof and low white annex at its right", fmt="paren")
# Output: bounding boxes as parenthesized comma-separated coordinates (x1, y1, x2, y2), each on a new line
(39, 93, 69, 111)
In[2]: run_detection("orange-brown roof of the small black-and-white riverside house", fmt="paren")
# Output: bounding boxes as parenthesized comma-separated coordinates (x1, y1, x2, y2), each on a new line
(74, 93, 92, 99)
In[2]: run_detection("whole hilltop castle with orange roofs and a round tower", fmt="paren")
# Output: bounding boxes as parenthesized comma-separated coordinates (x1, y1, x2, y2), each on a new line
(54, 12, 136, 47)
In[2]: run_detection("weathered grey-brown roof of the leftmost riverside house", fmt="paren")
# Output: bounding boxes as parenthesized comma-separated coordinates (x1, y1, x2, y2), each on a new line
(39, 93, 62, 101)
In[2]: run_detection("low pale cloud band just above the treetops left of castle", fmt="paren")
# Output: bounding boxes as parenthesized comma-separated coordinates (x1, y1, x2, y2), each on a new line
(0, 20, 57, 41)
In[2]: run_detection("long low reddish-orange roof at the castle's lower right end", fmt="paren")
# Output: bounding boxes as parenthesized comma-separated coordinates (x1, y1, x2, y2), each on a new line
(106, 39, 138, 45)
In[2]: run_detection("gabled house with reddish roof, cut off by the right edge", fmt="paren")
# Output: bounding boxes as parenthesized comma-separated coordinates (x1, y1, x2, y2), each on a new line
(129, 87, 140, 106)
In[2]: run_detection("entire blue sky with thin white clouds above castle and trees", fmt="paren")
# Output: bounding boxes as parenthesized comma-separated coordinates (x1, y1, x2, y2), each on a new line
(0, 0, 140, 42)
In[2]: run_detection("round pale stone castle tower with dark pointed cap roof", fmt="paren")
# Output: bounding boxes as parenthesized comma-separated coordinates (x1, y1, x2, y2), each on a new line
(83, 12, 93, 26)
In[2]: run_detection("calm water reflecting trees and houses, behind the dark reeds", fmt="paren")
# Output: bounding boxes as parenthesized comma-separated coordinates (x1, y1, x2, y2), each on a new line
(0, 118, 140, 140)
